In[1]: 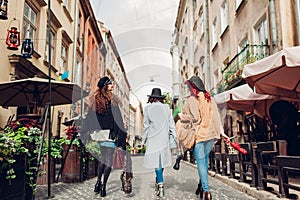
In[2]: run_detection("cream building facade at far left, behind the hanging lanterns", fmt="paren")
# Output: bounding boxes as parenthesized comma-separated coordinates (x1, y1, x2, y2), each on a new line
(0, 0, 77, 134)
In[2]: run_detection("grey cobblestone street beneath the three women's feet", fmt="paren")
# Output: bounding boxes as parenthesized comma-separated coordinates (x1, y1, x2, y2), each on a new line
(36, 156, 255, 200)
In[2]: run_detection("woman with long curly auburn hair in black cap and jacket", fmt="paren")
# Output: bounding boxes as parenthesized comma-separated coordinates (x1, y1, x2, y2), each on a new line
(82, 76, 127, 197)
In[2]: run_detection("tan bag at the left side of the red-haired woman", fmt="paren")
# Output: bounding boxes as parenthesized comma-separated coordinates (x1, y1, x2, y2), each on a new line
(176, 120, 196, 150)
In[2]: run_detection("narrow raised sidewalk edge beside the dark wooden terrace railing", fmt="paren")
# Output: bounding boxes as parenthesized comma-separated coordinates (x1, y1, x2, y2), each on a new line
(182, 161, 300, 200)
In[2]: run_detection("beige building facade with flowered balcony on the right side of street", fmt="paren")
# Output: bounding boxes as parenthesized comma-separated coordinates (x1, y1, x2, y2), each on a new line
(171, 0, 300, 139)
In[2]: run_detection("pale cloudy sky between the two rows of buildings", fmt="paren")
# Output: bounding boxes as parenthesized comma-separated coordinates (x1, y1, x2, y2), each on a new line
(90, 0, 179, 106)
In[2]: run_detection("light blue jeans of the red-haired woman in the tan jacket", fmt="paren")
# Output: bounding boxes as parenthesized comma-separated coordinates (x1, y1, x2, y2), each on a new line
(194, 139, 215, 192)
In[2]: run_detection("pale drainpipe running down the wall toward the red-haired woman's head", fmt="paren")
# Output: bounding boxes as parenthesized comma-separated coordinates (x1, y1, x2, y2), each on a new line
(202, 0, 211, 91)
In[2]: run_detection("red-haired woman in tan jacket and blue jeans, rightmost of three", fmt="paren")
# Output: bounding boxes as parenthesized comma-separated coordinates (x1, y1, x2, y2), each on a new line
(178, 76, 222, 199)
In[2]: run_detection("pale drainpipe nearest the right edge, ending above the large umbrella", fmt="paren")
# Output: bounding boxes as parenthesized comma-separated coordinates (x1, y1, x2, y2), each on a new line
(270, 0, 278, 53)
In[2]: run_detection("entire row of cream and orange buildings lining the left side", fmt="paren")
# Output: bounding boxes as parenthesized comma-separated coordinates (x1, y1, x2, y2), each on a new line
(0, 0, 136, 142)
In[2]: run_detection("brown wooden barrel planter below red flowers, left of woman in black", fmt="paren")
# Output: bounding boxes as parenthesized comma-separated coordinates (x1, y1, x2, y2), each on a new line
(62, 144, 80, 183)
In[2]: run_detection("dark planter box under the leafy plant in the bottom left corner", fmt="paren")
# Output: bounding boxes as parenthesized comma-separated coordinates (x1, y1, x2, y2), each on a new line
(0, 156, 26, 200)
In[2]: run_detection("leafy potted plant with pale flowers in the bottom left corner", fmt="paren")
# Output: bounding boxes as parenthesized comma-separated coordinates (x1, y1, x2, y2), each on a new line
(0, 118, 42, 199)
